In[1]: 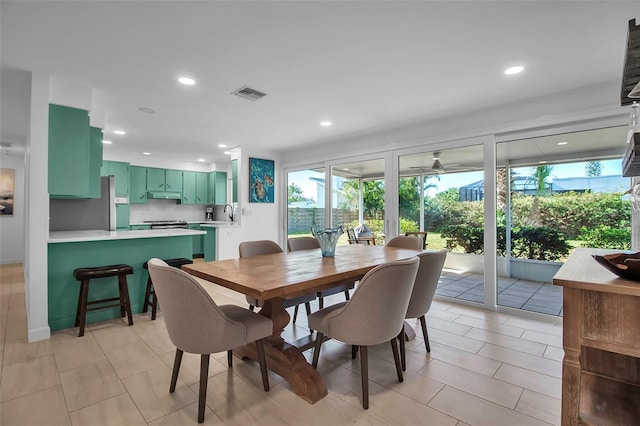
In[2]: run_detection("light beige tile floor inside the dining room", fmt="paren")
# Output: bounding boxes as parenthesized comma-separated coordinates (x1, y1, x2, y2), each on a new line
(0, 265, 563, 426)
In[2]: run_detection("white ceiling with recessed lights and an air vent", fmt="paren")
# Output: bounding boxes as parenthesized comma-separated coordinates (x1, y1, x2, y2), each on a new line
(0, 0, 640, 165)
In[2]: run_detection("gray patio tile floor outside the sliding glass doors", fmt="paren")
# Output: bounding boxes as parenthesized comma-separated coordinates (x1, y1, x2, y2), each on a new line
(436, 269, 562, 316)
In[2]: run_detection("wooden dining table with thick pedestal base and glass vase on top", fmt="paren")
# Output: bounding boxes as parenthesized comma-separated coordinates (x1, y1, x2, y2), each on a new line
(182, 244, 420, 404)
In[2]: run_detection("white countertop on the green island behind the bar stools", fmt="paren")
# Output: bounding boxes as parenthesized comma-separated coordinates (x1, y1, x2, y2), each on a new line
(48, 228, 206, 243)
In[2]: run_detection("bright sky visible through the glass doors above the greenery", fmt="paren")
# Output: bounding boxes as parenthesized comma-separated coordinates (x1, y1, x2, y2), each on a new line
(288, 159, 622, 201)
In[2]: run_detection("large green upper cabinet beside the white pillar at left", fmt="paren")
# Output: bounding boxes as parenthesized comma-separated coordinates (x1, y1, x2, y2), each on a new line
(49, 104, 93, 198)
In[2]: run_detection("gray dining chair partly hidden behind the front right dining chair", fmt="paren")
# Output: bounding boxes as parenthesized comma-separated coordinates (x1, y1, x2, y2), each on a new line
(398, 250, 447, 370)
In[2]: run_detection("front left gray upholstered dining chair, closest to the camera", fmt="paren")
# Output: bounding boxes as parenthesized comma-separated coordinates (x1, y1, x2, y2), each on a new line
(147, 258, 273, 423)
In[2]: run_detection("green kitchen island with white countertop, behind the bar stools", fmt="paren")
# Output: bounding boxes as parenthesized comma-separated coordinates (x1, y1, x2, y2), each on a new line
(47, 229, 206, 330)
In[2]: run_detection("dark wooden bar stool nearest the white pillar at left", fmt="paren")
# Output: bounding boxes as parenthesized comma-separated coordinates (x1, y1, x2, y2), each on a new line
(73, 264, 133, 337)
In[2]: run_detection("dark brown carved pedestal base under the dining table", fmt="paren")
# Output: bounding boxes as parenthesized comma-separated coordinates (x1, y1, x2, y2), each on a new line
(233, 298, 327, 404)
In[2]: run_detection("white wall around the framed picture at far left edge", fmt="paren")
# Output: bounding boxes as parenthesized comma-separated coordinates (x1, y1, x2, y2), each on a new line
(0, 148, 26, 264)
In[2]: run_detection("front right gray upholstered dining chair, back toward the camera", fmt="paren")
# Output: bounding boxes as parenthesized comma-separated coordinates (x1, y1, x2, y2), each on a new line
(309, 257, 419, 410)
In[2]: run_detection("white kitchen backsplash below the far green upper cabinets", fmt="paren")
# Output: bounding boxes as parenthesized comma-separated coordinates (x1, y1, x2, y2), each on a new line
(129, 200, 215, 223)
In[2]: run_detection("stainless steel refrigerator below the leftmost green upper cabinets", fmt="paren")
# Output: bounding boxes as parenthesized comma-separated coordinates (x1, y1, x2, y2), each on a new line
(49, 176, 116, 231)
